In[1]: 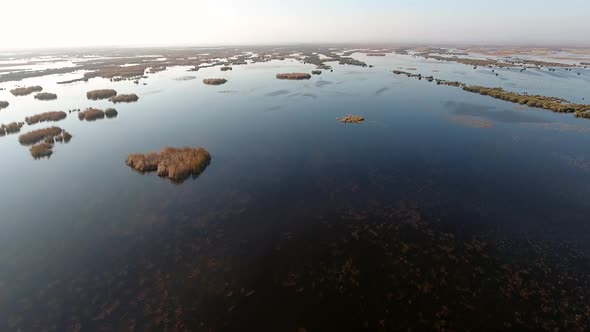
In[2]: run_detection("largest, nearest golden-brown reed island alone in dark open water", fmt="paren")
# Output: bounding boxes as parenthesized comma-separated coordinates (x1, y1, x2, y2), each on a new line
(126, 147, 211, 182)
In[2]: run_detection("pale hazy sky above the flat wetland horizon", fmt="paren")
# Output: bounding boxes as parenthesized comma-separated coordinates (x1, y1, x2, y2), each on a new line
(0, 0, 590, 48)
